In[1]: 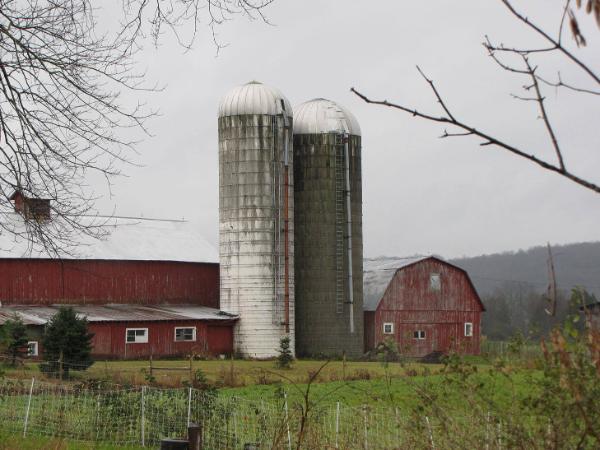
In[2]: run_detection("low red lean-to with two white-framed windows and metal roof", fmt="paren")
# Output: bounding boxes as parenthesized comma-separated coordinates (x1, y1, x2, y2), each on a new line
(0, 304, 237, 359)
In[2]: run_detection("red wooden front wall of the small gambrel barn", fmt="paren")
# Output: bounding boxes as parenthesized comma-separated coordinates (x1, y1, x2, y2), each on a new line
(365, 258, 484, 357)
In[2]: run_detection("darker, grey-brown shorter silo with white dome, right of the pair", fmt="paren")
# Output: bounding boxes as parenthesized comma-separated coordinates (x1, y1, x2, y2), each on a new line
(294, 98, 363, 356)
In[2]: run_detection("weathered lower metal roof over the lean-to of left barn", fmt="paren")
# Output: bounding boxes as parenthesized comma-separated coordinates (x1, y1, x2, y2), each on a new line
(0, 304, 238, 325)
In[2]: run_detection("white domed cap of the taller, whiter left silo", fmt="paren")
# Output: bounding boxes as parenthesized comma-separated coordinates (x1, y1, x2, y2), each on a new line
(219, 81, 293, 117)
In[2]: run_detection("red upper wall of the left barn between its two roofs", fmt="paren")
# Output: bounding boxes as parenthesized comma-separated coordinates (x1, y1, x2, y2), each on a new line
(0, 259, 219, 308)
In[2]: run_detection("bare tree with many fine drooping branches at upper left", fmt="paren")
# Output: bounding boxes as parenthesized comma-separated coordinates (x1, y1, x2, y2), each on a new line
(0, 0, 273, 253)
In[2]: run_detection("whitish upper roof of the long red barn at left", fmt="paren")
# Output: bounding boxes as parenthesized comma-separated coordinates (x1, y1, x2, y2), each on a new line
(0, 214, 219, 262)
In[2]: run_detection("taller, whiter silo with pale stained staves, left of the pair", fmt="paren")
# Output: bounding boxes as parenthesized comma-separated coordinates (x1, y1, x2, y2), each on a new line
(219, 81, 294, 358)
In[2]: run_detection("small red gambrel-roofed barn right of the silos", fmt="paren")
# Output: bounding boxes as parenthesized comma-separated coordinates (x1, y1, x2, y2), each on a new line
(364, 256, 485, 357)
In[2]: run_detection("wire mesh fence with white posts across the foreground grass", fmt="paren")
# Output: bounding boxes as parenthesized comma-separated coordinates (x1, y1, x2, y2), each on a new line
(0, 379, 506, 450)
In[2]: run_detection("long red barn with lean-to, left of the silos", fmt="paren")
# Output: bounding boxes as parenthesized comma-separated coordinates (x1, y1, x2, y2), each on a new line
(0, 202, 237, 359)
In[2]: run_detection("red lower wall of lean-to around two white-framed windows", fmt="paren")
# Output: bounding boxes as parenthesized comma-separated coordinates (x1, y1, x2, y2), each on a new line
(89, 320, 233, 359)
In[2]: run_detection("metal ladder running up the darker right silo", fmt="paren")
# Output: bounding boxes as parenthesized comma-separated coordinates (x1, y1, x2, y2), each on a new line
(335, 134, 346, 314)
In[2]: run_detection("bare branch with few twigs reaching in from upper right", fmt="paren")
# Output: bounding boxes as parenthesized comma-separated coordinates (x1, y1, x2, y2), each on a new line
(351, 0, 600, 194)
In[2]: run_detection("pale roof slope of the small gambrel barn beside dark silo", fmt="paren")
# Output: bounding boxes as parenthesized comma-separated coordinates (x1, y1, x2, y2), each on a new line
(363, 256, 431, 311)
